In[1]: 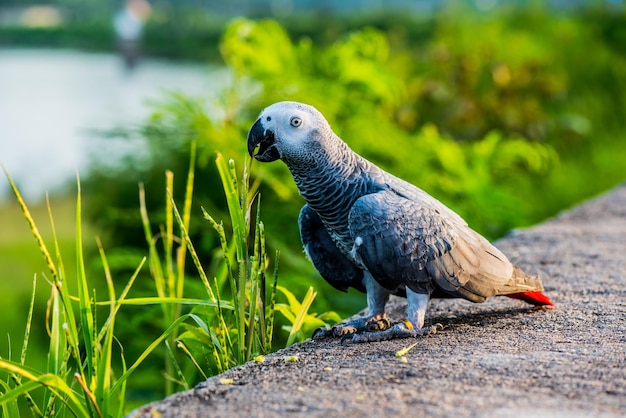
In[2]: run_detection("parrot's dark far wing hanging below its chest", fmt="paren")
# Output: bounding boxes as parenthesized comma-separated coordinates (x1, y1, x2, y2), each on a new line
(298, 205, 365, 292)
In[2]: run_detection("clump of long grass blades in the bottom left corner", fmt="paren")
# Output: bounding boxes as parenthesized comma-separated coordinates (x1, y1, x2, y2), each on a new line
(0, 165, 205, 417)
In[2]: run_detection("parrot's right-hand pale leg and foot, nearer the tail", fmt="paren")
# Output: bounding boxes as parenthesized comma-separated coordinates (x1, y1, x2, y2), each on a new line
(341, 288, 443, 344)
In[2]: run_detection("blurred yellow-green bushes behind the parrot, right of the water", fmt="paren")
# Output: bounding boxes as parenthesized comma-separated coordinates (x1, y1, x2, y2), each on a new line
(84, 4, 626, 324)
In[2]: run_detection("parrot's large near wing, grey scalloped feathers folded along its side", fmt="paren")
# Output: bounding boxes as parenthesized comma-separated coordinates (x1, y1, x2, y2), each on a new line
(349, 190, 513, 302)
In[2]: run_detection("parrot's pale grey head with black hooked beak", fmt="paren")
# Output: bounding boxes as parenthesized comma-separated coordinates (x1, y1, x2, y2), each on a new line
(248, 102, 332, 162)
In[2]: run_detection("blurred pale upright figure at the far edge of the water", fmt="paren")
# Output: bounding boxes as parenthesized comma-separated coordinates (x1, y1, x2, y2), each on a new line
(113, 0, 150, 70)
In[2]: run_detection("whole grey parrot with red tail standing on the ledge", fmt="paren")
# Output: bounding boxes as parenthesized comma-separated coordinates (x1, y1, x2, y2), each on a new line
(248, 102, 553, 342)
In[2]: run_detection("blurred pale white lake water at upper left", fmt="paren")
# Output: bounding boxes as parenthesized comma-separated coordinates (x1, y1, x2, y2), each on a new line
(0, 48, 229, 200)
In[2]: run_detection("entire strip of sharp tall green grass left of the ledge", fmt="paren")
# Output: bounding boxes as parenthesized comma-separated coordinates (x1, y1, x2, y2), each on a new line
(0, 149, 326, 417)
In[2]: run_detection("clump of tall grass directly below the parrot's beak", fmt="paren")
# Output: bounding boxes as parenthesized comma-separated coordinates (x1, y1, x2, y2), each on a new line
(150, 151, 278, 387)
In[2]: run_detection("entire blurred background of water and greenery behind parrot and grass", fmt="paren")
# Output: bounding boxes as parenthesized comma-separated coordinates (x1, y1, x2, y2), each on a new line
(0, 0, 626, 412)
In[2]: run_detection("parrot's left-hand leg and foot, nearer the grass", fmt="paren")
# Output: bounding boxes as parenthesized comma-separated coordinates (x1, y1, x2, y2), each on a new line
(311, 272, 391, 340)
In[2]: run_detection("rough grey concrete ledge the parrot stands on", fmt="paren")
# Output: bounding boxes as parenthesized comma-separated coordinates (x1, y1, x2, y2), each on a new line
(129, 185, 626, 418)
